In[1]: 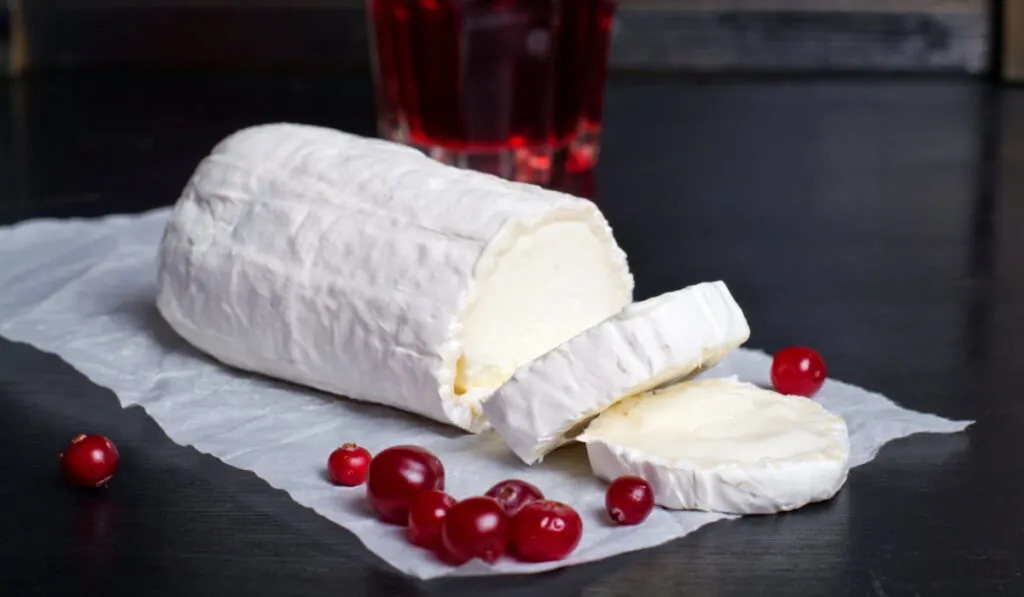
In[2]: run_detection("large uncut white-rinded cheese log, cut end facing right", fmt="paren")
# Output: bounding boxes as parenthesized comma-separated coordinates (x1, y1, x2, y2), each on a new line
(157, 124, 633, 431)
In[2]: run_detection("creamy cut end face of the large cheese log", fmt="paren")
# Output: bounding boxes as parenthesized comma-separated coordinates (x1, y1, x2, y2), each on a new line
(455, 220, 633, 402)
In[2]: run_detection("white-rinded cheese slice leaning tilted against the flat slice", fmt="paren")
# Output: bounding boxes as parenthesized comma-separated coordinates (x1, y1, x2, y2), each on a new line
(483, 282, 750, 464)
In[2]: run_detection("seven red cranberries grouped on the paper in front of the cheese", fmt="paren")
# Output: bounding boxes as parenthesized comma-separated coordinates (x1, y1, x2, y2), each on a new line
(328, 443, 654, 565)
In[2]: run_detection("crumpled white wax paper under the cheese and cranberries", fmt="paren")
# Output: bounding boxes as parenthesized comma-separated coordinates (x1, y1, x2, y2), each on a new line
(0, 209, 970, 579)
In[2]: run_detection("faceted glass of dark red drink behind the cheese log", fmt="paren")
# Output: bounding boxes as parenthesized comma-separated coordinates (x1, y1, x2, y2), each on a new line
(367, 0, 614, 184)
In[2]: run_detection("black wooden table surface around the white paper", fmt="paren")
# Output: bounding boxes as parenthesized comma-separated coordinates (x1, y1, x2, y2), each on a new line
(0, 73, 1024, 597)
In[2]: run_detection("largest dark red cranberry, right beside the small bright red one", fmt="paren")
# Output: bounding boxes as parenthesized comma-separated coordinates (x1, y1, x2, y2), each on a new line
(367, 445, 444, 524)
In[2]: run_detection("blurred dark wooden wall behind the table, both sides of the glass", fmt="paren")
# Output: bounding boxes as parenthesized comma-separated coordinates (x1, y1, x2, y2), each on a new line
(0, 0, 991, 75)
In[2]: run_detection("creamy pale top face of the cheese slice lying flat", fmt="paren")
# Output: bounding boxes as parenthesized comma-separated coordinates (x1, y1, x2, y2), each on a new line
(586, 379, 845, 466)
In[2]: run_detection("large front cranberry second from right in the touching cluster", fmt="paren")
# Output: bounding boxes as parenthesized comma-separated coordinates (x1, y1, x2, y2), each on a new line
(441, 497, 509, 564)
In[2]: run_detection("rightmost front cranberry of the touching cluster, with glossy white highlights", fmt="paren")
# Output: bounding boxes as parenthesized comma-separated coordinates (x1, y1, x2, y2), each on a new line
(512, 500, 583, 562)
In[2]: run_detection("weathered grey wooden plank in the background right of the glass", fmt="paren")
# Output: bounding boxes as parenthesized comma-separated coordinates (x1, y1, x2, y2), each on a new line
(612, 9, 990, 74)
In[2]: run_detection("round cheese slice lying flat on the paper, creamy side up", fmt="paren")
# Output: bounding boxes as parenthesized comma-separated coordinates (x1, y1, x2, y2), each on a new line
(579, 379, 850, 514)
